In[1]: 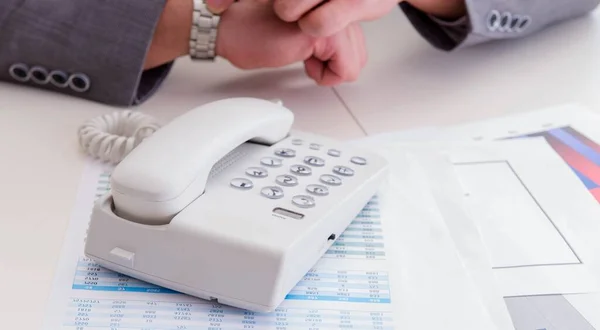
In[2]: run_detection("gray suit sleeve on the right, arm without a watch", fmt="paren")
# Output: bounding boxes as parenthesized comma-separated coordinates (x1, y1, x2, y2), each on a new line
(400, 0, 600, 51)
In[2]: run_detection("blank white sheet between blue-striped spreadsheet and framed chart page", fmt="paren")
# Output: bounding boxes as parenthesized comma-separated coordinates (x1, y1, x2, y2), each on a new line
(379, 149, 504, 330)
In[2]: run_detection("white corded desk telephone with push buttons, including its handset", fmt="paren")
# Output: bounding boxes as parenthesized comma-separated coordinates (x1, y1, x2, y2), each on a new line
(84, 98, 388, 312)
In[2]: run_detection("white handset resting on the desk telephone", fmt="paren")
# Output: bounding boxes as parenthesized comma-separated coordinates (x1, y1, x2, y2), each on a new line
(111, 98, 294, 225)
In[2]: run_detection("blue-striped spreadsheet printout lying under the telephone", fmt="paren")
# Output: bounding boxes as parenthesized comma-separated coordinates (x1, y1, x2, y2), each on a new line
(45, 163, 394, 330)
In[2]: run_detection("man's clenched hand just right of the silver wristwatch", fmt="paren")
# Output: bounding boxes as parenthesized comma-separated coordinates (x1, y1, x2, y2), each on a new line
(216, 0, 367, 86)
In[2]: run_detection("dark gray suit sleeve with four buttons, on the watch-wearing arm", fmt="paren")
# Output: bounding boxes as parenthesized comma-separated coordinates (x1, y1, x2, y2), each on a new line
(0, 0, 172, 106)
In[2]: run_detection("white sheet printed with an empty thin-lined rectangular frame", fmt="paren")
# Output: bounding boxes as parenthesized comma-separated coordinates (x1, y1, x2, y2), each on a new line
(420, 139, 600, 296)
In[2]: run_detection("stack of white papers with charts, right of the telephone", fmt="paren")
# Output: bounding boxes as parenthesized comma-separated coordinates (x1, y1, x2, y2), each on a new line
(357, 105, 600, 330)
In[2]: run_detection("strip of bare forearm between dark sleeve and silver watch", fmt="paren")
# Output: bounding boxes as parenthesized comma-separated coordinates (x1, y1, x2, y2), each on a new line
(144, 0, 194, 69)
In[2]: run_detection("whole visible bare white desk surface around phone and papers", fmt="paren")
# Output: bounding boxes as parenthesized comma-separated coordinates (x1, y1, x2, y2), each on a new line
(0, 6, 600, 329)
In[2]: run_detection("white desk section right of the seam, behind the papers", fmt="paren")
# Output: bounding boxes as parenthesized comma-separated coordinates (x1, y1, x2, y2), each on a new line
(336, 6, 600, 134)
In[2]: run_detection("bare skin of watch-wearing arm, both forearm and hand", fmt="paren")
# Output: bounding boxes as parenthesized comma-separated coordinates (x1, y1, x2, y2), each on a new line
(144, 0, 367, 86)
